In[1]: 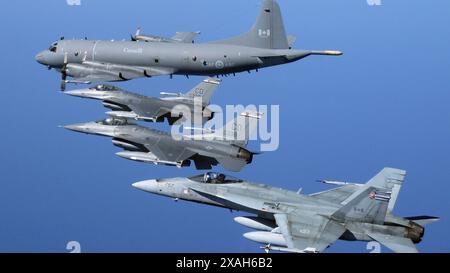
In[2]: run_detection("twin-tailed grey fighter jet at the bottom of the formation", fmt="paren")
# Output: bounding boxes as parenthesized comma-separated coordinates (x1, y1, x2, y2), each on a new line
(133, 168, 439, 253)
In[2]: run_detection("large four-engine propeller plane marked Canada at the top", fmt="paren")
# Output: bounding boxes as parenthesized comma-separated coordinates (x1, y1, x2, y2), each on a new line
(36, 0, 342, 90)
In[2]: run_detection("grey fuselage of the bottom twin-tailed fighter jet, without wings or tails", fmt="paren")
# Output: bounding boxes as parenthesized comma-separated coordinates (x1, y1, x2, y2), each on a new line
(133, 176, 423, 246)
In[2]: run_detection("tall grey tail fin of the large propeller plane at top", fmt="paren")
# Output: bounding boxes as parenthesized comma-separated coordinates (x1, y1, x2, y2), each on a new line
(215, 0, 289, 49)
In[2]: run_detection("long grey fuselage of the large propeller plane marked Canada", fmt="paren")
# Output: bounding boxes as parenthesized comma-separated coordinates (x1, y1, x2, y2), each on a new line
(36, 40, 311, 76)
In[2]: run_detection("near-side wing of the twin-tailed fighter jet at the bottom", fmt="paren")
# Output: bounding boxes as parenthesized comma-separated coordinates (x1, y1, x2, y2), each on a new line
(274, 214, 346, 252)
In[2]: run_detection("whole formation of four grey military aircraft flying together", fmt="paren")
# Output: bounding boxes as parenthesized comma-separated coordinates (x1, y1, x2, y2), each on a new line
(36, 0, 439, 253)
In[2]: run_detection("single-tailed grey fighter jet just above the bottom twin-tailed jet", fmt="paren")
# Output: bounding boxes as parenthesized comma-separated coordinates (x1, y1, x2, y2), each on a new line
(65, 112, 261, 172)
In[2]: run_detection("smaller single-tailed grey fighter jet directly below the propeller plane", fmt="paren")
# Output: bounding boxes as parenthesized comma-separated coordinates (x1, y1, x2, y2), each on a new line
(65, 78, 220, 125)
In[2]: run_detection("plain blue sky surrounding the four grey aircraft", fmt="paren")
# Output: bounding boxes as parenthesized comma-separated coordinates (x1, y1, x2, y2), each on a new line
(0, 0, 450, 252)
